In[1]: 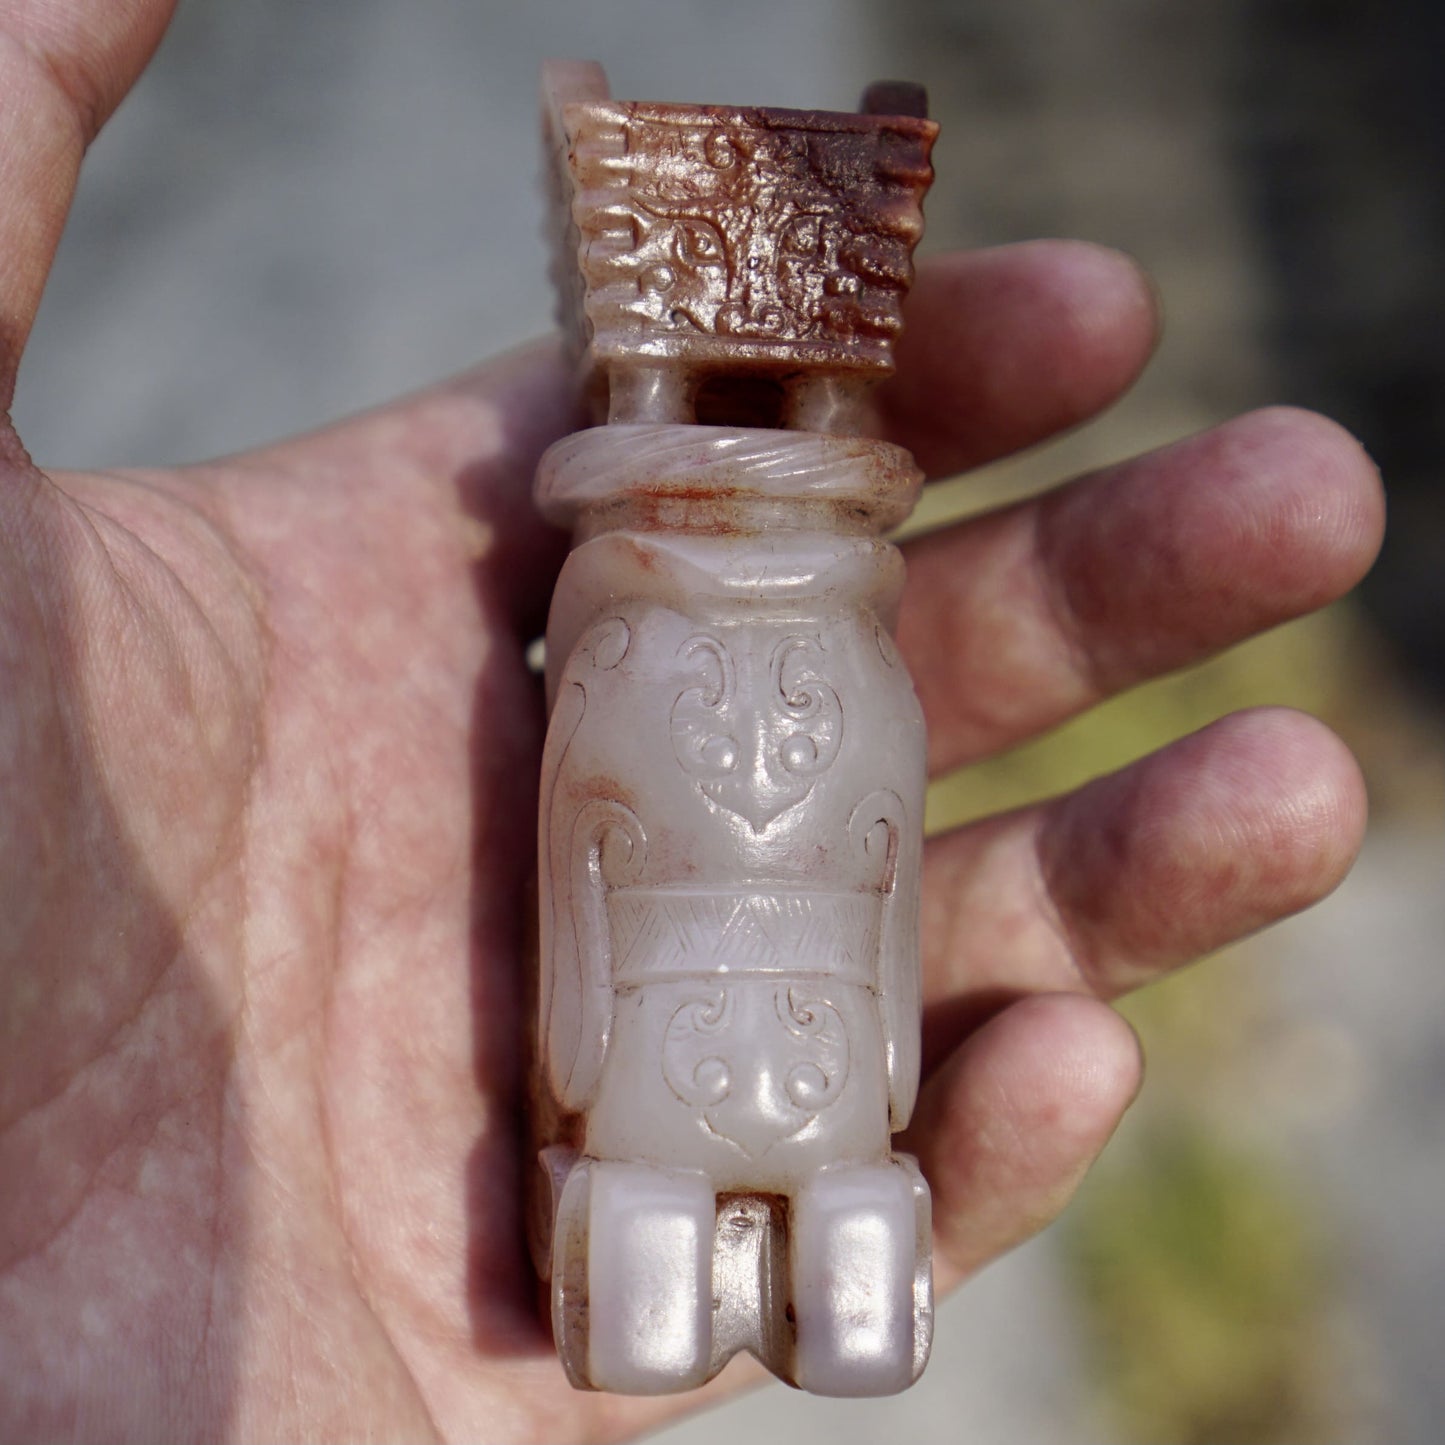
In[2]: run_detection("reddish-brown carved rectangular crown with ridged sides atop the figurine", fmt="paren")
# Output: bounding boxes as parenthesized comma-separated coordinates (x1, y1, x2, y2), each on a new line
(545, 62, 938, 374)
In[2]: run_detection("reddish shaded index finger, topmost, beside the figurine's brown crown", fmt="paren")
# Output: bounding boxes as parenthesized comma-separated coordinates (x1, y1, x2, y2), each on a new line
(879, 241, 1157, 477)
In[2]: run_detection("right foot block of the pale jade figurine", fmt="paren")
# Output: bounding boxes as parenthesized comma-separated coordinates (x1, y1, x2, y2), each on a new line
(792, 1159, 932, 1396)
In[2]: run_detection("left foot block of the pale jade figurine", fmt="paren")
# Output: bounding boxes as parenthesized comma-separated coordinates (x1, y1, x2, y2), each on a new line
(552, 1159, 715, 1394)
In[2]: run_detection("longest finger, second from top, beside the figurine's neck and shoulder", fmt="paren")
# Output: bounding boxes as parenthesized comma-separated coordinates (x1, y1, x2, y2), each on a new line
(899, 407, 1384, 772)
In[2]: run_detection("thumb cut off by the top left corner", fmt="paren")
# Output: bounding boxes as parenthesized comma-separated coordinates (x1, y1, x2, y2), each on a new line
(0, 0, 175, 418)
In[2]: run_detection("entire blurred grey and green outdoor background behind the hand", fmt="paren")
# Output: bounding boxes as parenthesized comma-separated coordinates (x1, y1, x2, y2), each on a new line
(16, 0, 1445, 1445)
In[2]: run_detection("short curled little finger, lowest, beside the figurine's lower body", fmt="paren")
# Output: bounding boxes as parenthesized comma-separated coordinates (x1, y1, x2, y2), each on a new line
(903, 994, 1143, 1289)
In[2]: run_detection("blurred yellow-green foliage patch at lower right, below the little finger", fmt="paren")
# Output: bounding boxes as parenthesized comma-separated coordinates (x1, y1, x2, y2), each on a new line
(1064, 1111, 1329, 1445)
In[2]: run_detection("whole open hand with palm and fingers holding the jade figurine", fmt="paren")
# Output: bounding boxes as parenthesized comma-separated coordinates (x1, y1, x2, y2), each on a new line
(0, 0, 1383, 1441)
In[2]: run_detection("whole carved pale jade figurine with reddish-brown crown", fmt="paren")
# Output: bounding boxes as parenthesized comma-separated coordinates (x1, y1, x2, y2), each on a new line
(530, 62, 936, 1394)
